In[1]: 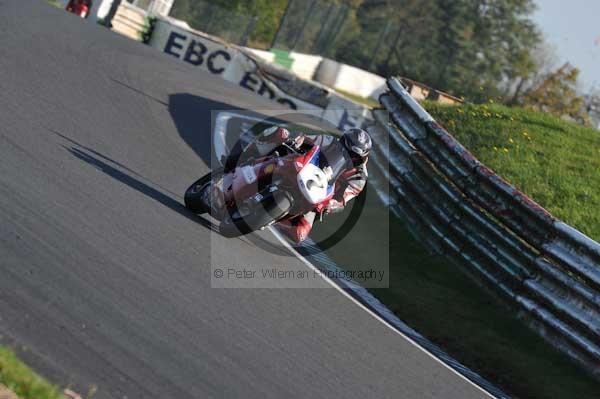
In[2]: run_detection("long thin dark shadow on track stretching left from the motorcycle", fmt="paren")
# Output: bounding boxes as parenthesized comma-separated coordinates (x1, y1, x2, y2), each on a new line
(63, 145, 219, 232)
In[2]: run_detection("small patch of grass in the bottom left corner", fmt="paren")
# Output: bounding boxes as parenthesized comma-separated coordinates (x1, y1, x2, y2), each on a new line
(0, 346, 65, 399)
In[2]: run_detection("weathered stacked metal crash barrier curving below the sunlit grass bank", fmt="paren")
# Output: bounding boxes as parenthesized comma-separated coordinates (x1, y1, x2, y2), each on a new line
(371, 78, 600, 377)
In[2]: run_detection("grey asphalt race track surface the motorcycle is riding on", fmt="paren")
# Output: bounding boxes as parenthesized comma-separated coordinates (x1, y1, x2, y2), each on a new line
(0, 0, 485, 399)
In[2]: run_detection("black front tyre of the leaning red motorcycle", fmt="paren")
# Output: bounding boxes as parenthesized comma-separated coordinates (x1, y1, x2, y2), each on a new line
(219, 191, 292, 238)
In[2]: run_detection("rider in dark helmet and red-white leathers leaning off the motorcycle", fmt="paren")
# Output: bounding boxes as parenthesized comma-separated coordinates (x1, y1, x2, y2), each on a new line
(225, 126, 372, 243)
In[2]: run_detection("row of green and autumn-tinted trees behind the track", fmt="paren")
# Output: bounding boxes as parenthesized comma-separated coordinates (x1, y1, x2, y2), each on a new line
(174, 0, 598, 123)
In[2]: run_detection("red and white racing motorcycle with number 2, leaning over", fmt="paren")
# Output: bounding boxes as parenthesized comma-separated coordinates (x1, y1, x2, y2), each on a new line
(184, 139, 335, 237)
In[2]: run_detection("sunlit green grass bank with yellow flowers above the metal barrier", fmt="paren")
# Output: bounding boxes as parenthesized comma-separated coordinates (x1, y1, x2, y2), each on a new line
(425, 103, 600, 241)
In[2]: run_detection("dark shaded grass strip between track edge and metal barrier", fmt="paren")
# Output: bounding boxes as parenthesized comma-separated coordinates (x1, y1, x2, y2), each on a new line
(313, 190, 600, 399)
